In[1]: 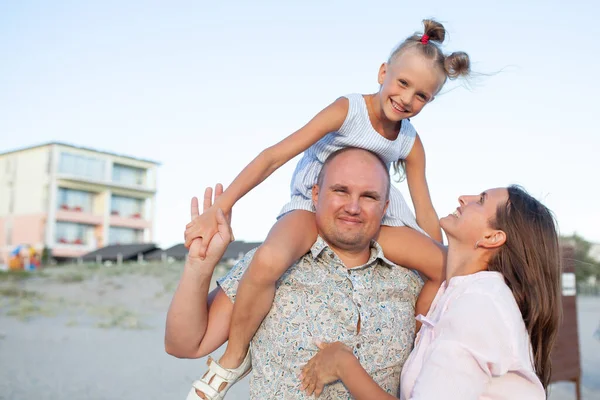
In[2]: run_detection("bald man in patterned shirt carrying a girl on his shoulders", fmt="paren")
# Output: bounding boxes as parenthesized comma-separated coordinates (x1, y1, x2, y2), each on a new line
(165, 149, 422, 399)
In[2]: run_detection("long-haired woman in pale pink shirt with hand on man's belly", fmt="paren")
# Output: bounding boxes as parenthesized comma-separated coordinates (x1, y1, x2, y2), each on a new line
(300, 186, 561, 400)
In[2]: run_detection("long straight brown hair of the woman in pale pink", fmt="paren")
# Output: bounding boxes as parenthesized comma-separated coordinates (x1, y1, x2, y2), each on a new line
(488, 186, 562, 389)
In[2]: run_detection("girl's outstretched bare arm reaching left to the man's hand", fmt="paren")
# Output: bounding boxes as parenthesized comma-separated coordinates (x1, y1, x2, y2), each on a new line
(185, 97, 349, 257)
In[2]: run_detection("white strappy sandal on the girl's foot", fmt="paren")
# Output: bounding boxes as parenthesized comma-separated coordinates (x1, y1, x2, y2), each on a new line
(186, 349, 252, 400)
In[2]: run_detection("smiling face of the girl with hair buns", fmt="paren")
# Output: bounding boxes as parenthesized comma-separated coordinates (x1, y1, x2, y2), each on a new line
(378, 48, 446, 122)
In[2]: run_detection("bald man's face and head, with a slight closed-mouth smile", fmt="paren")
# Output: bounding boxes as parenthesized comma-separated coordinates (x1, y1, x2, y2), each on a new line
(313, 150, 389, 251)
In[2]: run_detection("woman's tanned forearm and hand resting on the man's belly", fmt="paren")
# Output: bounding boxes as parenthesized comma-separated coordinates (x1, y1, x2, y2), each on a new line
(300, 342, 398, 400)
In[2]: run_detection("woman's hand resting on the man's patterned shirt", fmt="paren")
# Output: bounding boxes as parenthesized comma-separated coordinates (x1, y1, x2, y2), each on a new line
(299, 341, 354, 397)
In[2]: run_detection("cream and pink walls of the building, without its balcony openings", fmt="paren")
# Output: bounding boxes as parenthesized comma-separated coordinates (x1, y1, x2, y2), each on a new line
(0, 144, 156, 257)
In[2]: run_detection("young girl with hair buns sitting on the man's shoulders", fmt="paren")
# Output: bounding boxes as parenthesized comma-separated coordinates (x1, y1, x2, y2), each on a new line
(185, 20, 469, 399)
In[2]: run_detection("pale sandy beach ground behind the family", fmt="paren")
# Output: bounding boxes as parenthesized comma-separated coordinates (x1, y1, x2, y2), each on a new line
(0, 264, 600, 400)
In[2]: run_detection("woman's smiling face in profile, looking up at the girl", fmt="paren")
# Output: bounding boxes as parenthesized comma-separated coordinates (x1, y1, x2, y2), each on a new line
(440, 188, 508, 247)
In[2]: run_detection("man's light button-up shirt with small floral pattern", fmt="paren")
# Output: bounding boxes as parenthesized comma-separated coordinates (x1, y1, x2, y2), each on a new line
(218, 238, 423, 400)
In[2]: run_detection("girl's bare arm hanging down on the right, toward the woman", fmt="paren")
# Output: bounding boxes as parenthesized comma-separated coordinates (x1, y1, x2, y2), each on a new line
(405, 135, 442, 243)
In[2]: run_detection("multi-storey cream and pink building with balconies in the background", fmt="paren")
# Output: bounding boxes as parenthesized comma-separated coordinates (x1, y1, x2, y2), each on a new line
(0, 142, 159, 259)
